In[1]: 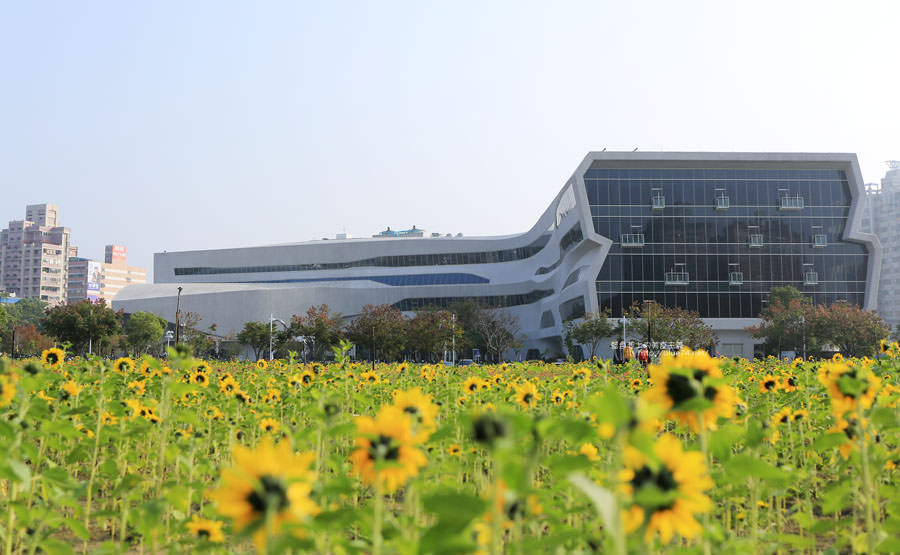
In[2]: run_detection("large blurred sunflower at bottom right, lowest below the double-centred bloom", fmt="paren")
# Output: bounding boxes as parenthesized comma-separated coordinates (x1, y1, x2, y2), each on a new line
(619, 434, 714, 544)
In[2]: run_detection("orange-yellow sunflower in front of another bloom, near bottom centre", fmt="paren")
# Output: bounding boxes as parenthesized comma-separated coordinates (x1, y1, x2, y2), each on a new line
(350, 405, 428, 493)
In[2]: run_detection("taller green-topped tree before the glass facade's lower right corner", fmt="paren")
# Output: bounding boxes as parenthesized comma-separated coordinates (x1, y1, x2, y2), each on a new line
(747, 286, 820, 356)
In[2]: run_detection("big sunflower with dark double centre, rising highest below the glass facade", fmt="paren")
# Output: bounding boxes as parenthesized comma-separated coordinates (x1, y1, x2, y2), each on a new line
(642, 349, 740, 432)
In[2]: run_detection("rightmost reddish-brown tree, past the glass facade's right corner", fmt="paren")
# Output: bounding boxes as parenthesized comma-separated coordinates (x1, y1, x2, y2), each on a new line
(811, 301, 891, 357)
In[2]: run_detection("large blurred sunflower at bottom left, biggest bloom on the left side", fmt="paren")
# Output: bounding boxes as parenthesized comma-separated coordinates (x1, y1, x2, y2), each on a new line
(207, 436, 320, 551)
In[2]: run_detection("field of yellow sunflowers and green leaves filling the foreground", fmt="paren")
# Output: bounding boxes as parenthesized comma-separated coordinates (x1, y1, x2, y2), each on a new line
(0, 344, 900, 554)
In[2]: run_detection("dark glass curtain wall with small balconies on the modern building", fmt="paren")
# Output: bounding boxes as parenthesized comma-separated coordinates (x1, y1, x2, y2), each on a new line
(584, 166, 868, 318)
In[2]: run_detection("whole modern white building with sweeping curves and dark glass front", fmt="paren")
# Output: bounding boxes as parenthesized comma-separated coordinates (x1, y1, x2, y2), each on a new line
(113, 152, 881, 357)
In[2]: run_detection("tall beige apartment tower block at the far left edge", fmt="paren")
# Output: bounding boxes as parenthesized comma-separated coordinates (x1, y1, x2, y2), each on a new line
(0, 204, 78, 304)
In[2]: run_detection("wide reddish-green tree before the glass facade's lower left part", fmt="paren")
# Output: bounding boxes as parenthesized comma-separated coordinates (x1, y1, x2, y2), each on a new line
(616, 302, 718, 356)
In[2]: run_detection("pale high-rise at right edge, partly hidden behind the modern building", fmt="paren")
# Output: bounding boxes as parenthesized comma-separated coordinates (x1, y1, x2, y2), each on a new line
(862, 161, 900, 328)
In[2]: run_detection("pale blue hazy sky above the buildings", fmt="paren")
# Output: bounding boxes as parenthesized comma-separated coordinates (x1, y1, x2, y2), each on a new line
(0, 0, 900, 278)
